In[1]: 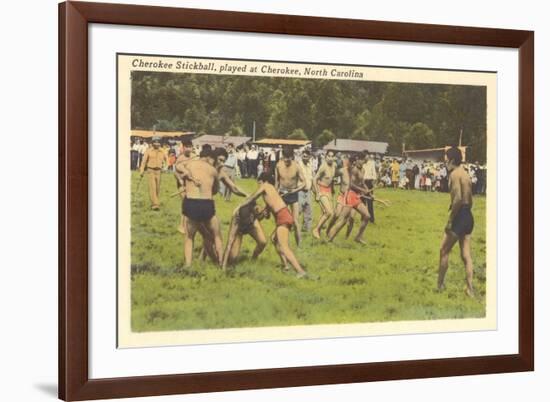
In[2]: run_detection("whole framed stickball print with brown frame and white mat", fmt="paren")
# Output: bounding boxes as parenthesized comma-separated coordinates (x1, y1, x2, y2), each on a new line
(59, 2, 534, 400)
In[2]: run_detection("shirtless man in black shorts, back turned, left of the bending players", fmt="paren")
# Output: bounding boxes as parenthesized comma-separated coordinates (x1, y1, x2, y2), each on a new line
(182, 147, 223, 267)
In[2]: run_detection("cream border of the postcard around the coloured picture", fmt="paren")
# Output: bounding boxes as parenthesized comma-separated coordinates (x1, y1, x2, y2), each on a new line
(115, 52, 498, 348)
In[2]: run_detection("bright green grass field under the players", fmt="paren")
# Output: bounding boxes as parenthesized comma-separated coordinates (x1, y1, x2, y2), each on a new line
(131, 173, 485, 332)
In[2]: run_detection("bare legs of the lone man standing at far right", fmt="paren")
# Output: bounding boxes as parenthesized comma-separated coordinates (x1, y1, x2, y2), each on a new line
(437, 231, 474, 297)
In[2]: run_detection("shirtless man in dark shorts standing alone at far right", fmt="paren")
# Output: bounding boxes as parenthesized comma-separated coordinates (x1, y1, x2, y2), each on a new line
(437, 147, 474, 297)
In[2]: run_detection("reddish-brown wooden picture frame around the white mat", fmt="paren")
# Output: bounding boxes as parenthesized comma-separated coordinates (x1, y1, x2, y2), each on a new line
(59, 2, 534, 400)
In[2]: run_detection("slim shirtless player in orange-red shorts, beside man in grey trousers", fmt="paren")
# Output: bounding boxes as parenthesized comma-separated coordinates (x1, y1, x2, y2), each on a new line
(312, 151, 336, 239)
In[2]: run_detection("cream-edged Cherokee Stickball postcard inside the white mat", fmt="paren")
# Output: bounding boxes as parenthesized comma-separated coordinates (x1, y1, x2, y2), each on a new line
(116, 54, 497, 348)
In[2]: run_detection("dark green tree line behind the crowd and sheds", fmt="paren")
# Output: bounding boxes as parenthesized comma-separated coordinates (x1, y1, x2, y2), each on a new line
(131, 71, 487, 163)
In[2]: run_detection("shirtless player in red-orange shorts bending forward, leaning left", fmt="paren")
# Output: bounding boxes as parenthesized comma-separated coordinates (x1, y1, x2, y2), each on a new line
(239, 173, 308, 278)
